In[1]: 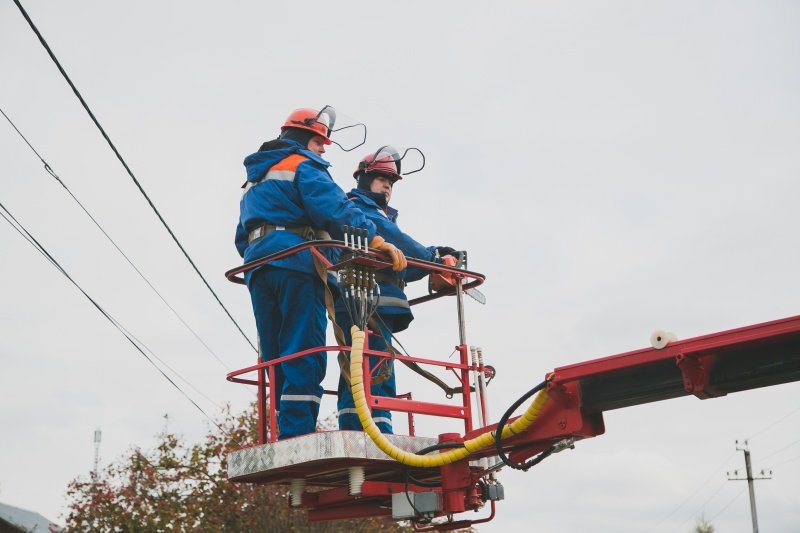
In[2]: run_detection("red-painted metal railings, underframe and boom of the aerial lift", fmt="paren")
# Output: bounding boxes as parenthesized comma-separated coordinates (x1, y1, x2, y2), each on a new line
(226, 241, 800, 531)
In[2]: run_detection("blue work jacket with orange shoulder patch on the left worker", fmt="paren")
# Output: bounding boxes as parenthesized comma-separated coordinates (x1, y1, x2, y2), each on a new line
(236, 139, 376, 283)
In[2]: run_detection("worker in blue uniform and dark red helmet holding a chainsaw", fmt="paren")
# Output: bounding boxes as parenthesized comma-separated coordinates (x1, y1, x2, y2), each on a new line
(336, 146, 455, 433)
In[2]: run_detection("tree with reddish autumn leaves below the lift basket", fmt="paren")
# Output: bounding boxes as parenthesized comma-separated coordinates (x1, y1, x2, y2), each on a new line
(66, 409, 408, 533)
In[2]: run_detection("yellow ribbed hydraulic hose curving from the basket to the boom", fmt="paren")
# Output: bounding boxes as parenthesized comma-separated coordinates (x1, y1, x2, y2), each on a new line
(350, 326, 548, 468)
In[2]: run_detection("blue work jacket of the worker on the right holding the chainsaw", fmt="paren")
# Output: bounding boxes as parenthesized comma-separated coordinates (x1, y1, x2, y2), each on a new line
(336, 185, 436, 332)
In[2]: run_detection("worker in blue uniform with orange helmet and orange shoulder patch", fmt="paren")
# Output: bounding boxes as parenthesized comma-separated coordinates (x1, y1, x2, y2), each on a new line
(236, 108, 406, 439)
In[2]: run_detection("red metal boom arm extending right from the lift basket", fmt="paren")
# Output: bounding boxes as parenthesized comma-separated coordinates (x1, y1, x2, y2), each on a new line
(466, 316, 800, 461)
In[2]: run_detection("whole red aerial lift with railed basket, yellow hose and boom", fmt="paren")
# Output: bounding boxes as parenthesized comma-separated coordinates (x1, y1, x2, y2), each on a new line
(222, 241, 800, 531)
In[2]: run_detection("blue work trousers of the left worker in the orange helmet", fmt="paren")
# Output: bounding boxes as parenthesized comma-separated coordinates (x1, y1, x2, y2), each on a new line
(249, 267, 327, 440)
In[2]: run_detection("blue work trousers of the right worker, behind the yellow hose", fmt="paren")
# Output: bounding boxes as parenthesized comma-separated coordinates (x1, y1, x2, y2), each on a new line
(336, 312, 397, 433)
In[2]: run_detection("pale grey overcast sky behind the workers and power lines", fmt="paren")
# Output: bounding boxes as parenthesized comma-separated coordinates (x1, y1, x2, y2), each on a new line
(0, 0, 800, 533)
